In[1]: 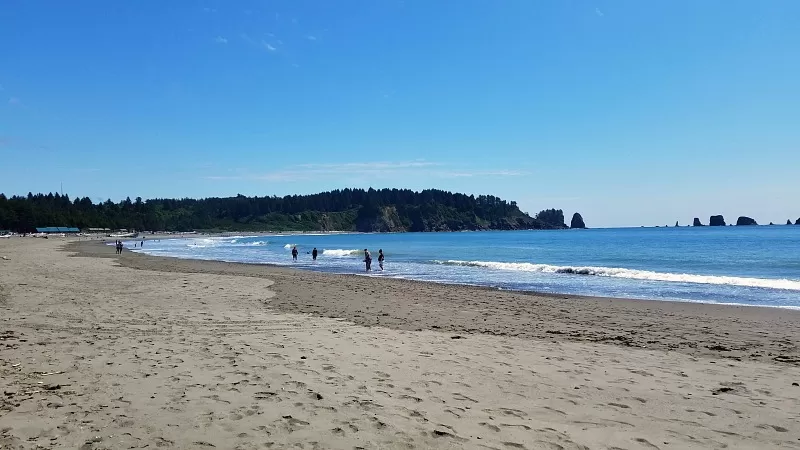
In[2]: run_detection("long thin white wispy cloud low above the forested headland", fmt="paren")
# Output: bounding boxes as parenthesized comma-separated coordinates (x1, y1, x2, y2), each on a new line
(205, 160, 525, 182)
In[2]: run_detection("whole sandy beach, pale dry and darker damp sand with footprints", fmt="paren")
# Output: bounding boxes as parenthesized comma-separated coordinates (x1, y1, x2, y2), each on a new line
(0, 238, 800, 450)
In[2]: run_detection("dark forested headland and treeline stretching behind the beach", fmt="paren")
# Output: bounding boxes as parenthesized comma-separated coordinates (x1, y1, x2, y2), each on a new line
(0, 188, 580, 232)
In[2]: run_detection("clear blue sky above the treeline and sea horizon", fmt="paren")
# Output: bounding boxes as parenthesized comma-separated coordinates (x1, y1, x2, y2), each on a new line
(0, 0, 800, 226)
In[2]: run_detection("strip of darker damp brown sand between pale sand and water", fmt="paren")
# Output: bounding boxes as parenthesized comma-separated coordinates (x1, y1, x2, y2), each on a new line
(69, 241, 800, 365)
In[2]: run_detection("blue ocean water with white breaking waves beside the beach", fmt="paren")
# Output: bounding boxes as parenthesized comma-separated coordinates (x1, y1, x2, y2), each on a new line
(126, 229, 800, 308)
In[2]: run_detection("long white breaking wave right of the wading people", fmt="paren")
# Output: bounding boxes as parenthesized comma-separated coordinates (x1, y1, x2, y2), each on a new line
(434, 260, 800, 291)
